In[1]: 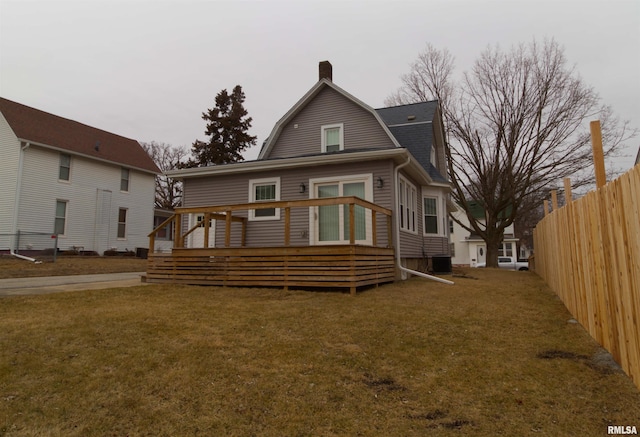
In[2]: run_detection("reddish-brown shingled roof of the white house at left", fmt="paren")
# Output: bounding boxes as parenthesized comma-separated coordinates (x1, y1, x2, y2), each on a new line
(0, 97, 160, 174)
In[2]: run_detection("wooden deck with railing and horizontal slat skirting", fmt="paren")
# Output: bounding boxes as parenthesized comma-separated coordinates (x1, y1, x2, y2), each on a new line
(146, 197, 396, 294)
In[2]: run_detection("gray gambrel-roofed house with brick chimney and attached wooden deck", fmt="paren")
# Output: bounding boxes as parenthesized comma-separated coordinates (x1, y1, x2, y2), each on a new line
(148, 61, 450, 291)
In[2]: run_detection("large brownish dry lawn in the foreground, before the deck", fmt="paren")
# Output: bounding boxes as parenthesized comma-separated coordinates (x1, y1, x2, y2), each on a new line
(0, 269, 640, 436)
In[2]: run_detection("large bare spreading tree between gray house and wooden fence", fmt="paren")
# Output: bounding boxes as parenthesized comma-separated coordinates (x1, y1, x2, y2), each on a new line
(386, 40, 637, 267)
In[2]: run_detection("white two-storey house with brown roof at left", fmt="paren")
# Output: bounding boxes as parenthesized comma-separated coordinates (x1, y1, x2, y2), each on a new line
(0, 98, 159, 254)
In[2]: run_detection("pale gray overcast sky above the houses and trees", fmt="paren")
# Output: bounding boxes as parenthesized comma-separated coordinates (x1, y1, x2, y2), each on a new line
(0, 0, 640, 169)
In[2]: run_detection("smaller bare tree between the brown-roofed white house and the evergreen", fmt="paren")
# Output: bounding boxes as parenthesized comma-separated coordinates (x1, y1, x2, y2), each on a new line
(140, 141, 188, 210)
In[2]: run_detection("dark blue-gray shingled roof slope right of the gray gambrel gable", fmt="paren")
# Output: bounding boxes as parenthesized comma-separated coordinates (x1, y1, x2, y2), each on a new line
(376, 100, 447, 183)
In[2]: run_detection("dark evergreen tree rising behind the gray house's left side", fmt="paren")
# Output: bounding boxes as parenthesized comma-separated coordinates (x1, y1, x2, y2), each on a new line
(184, 85, 256, 168)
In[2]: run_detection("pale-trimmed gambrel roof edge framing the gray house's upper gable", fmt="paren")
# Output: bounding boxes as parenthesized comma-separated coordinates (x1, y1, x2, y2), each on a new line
(258, 79, 402, 160)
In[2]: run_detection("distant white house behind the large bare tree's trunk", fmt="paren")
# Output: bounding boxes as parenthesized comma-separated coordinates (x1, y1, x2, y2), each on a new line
(449, 200, 518, 267)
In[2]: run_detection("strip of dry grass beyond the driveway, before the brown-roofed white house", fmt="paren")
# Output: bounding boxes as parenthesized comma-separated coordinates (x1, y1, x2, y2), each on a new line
(0, 256, 147, 279)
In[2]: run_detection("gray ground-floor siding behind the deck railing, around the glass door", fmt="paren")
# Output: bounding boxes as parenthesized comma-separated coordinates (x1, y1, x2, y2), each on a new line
(178, 160, 393, 247)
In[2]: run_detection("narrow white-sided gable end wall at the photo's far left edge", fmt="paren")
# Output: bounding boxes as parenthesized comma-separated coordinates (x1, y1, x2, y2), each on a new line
(0, 113, 20, 238)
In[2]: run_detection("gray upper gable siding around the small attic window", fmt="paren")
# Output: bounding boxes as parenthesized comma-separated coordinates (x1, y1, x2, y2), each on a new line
(265, 87, 394, 159)
